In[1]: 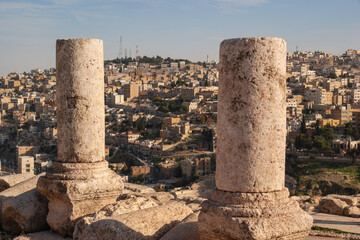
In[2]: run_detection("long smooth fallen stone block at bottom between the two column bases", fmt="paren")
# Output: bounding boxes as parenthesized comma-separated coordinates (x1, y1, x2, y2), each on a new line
(78, 202, 192, 240)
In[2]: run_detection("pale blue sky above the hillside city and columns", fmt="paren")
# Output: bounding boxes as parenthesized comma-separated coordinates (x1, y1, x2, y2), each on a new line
(0, 0, 360, 76)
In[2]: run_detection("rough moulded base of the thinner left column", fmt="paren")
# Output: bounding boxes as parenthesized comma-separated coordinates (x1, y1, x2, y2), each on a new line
(37, 161, 124, 236)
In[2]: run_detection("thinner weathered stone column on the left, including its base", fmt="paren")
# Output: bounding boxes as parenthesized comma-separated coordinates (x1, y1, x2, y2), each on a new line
(37, 39, 123, 236)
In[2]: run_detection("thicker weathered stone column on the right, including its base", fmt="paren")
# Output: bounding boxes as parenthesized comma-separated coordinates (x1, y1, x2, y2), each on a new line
(199, 37, 312, 239)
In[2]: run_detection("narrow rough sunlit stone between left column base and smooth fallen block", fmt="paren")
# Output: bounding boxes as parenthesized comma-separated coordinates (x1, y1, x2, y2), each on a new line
(73, 196, 158, 238)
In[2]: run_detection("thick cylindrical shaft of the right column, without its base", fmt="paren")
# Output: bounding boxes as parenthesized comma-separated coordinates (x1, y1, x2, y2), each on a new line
(216, 37, 286, 192)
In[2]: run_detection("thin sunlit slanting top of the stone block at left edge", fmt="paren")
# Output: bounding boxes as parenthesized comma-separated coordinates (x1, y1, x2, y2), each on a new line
(0, 173, 45, 224)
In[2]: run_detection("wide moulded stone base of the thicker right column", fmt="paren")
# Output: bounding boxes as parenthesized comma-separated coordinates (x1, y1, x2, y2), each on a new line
(198, 188, 313, 240)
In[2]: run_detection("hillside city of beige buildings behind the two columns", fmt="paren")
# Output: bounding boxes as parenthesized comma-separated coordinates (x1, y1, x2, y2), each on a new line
(0, 50, 360, 194)
